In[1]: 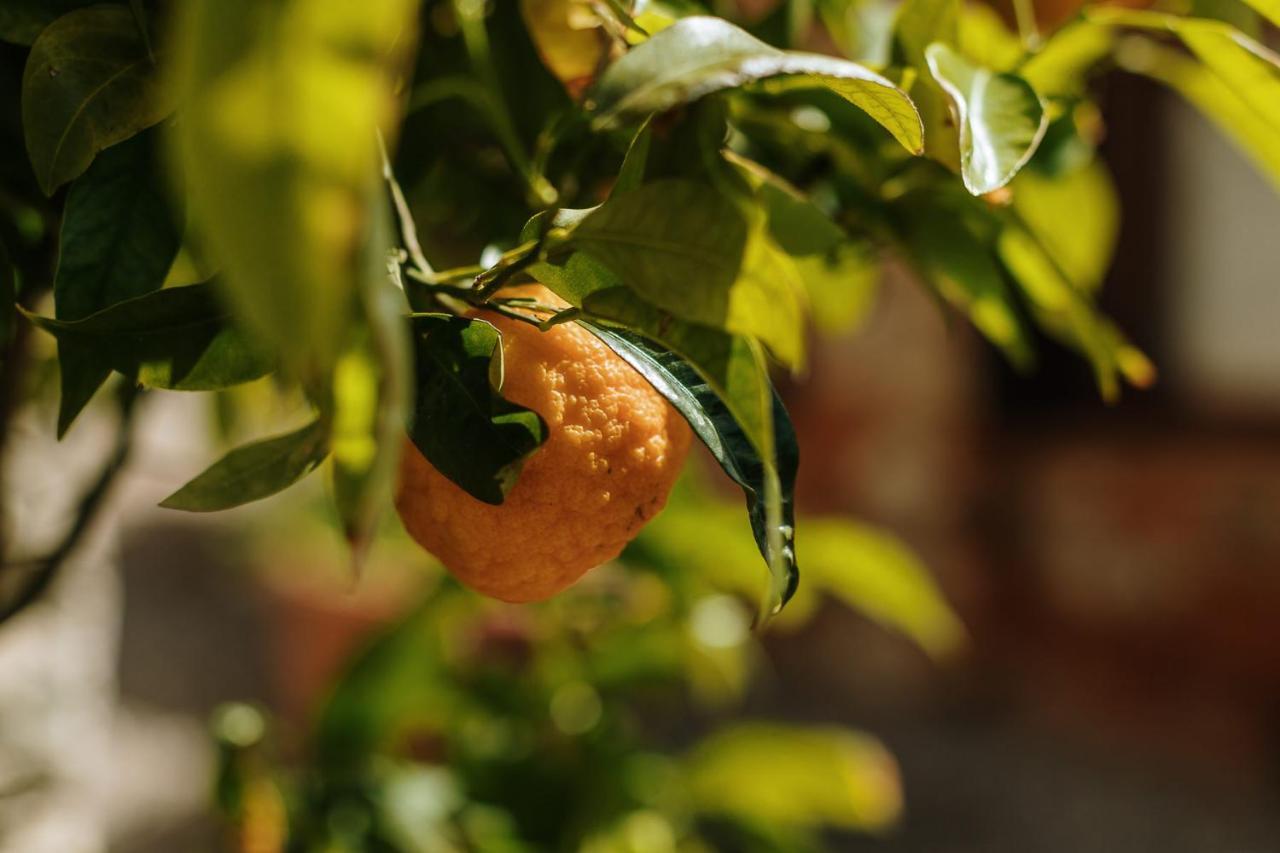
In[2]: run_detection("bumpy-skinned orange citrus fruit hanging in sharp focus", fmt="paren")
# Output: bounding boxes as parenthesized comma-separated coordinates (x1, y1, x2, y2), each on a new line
(396, 287, 691, 602)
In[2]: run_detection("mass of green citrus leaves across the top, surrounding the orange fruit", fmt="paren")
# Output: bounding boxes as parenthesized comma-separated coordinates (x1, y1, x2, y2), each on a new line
(0, 0, 1280, 611)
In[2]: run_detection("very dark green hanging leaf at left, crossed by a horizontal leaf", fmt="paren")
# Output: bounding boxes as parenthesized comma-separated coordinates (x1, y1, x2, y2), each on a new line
(54, 131, 182, 437)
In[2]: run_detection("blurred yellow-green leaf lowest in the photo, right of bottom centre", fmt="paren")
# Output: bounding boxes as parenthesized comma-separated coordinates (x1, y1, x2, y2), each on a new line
(684, 722, 902, 831)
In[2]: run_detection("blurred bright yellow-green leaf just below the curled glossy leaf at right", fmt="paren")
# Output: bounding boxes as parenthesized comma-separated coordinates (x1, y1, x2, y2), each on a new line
(1012, 160, 1120, 292)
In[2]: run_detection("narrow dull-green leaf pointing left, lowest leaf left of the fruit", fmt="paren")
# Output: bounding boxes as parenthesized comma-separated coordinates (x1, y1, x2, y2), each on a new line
(160, 420, 329, 512)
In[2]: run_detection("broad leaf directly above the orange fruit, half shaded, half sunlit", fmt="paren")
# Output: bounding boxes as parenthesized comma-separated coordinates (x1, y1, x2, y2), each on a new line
(567, 179, 804, 365)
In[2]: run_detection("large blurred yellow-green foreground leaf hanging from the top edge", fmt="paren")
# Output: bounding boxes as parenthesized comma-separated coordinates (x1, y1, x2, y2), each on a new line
(173, 0, 417, 384)
